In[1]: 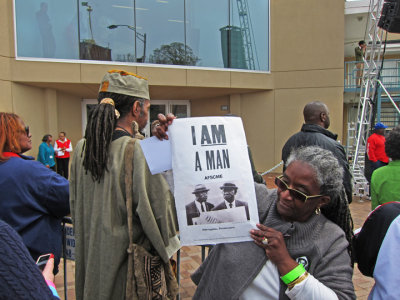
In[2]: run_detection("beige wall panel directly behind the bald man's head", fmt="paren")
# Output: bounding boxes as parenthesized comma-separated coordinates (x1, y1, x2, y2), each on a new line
(274, 88, 343, 166)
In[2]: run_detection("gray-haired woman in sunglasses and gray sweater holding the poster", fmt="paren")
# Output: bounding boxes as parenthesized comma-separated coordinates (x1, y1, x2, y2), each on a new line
(192, 146, 356, 300)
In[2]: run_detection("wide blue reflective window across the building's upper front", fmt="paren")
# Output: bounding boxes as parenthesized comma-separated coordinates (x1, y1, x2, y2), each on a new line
(14, 0, 270, 71)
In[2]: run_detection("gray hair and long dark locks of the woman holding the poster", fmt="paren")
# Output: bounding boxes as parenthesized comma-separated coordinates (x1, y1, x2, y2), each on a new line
(286, 146, 354, 265)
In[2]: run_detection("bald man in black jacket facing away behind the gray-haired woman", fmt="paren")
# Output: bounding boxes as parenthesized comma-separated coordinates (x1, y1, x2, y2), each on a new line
(282, 101, 352, 203)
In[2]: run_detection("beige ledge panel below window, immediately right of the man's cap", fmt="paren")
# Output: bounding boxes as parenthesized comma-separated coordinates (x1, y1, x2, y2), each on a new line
(137, 66, 186, 85)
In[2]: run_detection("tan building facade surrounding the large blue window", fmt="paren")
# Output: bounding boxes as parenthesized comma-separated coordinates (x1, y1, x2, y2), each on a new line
(0, 0, 344, 171)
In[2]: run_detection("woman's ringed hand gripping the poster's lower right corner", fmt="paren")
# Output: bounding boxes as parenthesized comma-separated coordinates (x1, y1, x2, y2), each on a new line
(250, 224, 298, 276)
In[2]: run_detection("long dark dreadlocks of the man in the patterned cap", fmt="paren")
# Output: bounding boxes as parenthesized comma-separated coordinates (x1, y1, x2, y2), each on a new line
(81, 92, 144, 181)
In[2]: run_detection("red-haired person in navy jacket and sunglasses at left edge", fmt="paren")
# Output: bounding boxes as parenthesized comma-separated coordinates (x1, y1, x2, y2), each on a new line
(0, 112, 70, 273)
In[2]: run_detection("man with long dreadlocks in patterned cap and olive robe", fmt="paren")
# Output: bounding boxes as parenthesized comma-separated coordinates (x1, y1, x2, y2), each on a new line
(70, 70, 180, 300)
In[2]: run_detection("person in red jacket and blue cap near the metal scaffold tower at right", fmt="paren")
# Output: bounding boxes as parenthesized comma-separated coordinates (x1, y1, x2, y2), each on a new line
(367, 122, 389, 174)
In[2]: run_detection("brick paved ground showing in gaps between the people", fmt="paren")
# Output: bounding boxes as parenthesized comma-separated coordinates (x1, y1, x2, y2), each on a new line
(56, 175, 374, 300)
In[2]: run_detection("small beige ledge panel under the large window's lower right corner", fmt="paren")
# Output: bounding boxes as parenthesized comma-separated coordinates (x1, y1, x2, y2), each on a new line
(231, 72, 274, 90)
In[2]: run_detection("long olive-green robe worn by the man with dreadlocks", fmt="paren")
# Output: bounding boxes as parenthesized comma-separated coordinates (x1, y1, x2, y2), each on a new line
(70, 137, 180, 300)
